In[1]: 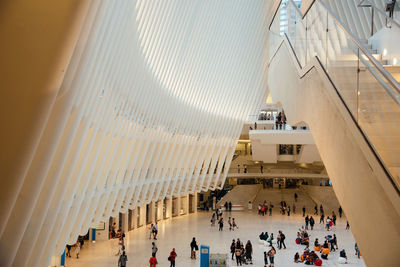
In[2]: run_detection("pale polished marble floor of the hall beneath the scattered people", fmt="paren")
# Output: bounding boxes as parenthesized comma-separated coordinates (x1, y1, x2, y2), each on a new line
(66, 211, 365, 267)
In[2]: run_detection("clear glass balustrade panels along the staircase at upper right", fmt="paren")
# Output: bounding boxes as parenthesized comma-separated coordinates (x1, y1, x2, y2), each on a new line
(270, 0, 400, 192)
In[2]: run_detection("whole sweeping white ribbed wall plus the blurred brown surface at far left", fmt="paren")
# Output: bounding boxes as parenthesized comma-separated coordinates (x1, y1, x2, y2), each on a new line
(0, 0, 279, 267)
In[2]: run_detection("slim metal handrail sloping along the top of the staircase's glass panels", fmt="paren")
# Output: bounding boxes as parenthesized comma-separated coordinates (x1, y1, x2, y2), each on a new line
(288, 0, 400, 105)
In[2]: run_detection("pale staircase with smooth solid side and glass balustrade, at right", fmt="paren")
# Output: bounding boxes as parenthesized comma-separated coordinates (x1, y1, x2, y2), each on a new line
(268, 0, 400, 266)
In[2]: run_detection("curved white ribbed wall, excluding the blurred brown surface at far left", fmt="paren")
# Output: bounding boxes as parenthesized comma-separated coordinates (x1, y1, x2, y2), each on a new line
(0, 0, 274, 266)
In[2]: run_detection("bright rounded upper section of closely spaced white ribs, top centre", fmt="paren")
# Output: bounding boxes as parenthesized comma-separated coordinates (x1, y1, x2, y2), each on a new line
(136, 0, 267, 116)
